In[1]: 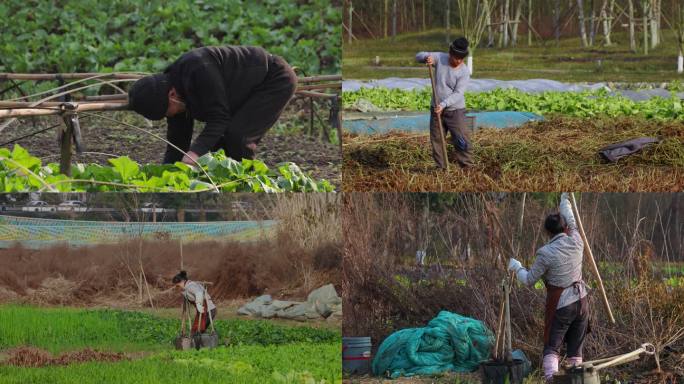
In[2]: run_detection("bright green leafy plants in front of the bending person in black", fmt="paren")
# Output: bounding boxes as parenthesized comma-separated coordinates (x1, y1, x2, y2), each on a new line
(0, 145, 335, 192)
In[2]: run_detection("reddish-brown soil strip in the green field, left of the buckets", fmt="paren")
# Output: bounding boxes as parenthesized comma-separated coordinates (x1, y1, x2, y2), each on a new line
(5, 347, 129, 368)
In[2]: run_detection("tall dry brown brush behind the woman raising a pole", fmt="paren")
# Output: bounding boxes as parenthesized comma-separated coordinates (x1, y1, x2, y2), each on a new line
(342, 193, 684, 382)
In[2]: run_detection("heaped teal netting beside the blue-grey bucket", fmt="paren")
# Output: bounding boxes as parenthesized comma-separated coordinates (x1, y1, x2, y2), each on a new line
(372, 311, 494, 378)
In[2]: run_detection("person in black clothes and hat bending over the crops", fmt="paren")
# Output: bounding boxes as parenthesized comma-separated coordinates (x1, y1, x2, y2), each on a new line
(128, 46, 297, 164)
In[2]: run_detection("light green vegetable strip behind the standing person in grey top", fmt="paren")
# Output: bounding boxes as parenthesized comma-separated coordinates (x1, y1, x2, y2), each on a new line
(342, 88, 684, 120)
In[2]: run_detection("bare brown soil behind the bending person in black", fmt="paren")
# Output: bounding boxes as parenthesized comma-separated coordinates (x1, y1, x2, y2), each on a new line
(0, 106, 342, 187)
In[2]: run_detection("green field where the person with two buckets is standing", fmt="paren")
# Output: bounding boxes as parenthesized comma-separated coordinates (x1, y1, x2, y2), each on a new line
(0, 306, 342, 383)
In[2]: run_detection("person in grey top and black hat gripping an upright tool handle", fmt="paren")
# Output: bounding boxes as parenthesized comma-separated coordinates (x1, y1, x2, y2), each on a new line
(416, 37, 472, 169)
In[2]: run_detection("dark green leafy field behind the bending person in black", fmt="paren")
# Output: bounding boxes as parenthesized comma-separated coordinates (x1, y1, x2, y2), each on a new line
(0, 0, 341, 74)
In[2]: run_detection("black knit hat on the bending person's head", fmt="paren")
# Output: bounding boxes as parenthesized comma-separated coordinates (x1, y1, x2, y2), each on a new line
(128, 73, 171, 120)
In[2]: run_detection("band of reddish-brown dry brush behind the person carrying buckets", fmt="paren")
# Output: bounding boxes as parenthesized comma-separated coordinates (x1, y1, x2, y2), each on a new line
(0, 236, 341, 307)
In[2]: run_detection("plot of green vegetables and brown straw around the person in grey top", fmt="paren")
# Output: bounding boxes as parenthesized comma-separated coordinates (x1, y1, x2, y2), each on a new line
(343, 89, 684, 191)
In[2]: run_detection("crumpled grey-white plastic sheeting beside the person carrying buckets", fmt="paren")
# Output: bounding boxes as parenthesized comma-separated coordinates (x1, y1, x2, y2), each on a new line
(238, 284, 342, 321)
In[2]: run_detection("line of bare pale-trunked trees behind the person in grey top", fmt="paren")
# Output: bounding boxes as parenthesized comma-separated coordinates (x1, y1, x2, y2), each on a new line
(344, 0, 684, 52)
